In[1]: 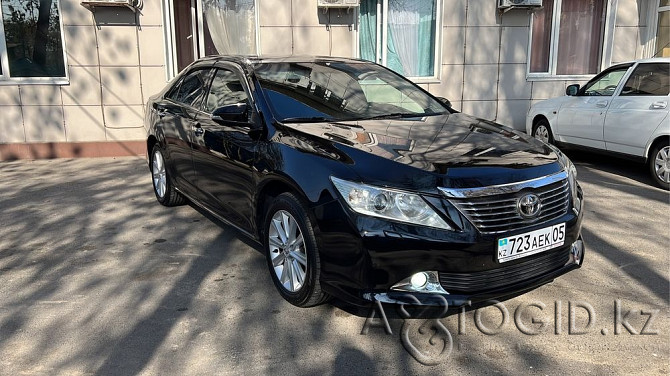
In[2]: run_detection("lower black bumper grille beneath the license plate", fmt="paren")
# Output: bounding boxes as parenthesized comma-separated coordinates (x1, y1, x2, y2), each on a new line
(439, 250, 570, 294)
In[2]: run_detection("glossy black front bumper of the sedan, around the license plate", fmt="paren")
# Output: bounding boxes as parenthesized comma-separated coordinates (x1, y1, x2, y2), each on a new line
(315, 187, 583, 307)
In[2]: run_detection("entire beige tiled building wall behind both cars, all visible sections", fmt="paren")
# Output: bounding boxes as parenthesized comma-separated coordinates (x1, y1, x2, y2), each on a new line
(0, 0, 649, 153)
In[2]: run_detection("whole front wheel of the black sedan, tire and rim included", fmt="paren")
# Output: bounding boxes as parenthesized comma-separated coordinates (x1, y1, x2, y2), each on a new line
(263, 193, 328, 307)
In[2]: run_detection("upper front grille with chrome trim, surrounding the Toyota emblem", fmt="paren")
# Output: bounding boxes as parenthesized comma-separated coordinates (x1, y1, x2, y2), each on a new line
(450, 179, 570, 234)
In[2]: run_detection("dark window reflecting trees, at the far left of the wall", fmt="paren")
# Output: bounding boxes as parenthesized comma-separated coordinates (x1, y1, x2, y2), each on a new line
(0, 0, 65, 81)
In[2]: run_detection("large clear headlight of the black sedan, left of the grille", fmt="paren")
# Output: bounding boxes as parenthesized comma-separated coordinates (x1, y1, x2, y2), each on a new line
(330, 177, 453, 230)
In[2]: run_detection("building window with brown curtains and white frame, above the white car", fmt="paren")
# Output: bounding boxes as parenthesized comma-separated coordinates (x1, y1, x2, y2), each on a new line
(528, 0, 606, 75)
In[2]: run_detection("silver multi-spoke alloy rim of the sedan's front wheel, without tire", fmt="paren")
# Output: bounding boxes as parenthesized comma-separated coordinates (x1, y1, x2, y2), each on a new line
(268, 210, 307, 293)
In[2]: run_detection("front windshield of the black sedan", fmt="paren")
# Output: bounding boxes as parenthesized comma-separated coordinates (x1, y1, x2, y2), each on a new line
(255, 62, 448, 122)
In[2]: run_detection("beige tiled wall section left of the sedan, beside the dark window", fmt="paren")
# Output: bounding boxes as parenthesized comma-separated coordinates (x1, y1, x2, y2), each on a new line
(0, 0, 166, 150)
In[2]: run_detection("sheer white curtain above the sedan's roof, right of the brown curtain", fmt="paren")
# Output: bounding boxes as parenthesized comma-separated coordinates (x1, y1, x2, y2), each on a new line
(203, 0, 256, 55)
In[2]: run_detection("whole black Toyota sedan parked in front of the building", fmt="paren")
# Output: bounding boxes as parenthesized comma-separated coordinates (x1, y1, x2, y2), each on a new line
(146, 56, 584, 307)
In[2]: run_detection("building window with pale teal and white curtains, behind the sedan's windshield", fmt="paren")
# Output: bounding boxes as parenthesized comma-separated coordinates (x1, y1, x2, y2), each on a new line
(359, 0, 441, 78)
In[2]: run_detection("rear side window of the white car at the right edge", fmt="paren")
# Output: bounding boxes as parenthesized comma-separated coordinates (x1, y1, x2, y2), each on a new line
(621, 63, 670, 96)
